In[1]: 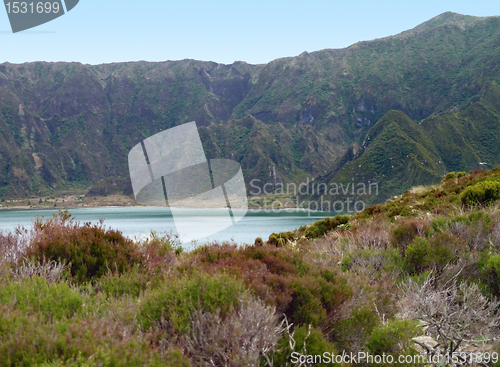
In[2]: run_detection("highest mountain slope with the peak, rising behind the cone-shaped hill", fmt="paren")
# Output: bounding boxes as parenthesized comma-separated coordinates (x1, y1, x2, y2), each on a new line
(235, 13, 500, 132)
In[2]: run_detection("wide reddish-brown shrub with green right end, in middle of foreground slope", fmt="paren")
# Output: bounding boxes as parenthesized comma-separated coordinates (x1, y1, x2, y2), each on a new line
(190, 246, 352, 326)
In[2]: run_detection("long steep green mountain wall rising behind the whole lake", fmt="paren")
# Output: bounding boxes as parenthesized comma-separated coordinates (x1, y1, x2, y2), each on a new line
(0, 13, 500, 201)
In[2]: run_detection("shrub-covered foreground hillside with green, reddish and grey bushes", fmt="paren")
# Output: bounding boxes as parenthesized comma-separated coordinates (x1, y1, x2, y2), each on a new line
(0, 167, 500, 367)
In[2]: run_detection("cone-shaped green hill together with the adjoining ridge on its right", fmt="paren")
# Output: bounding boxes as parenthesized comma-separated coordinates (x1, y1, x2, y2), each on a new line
(311, 86, 500, 204)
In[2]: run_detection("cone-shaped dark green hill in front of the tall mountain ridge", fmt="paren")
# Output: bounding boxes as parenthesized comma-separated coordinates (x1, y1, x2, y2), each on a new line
(310, 110, 442, 207)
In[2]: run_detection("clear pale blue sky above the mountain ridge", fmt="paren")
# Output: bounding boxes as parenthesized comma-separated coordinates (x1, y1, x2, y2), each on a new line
(0, 0, 500, 64)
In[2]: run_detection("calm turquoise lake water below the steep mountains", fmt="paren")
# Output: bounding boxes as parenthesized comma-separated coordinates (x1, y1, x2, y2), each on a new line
(0, 207, 336, 247)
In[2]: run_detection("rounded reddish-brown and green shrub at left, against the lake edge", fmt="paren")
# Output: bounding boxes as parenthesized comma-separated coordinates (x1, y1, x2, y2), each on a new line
(26, 212, 142, 283)
